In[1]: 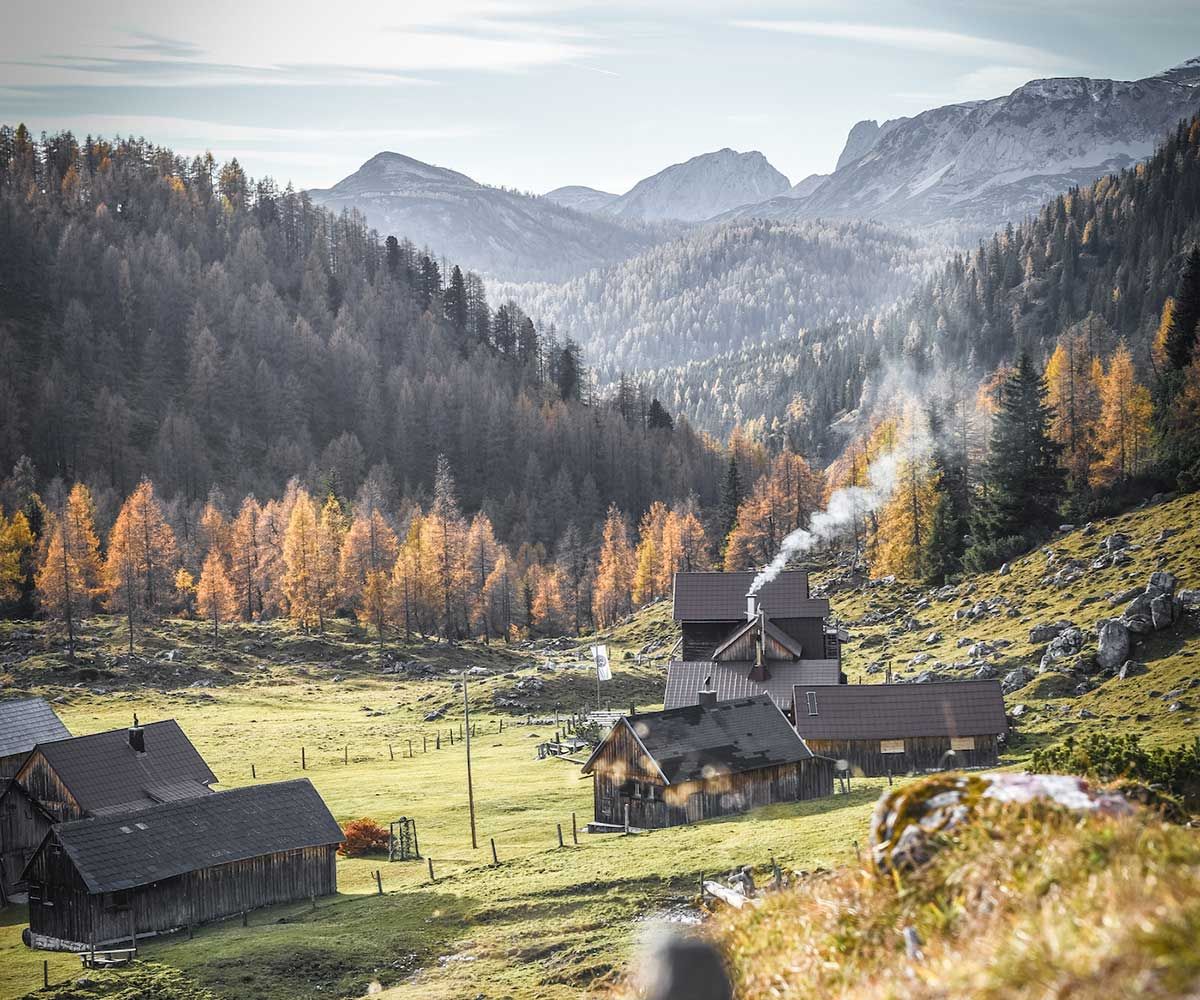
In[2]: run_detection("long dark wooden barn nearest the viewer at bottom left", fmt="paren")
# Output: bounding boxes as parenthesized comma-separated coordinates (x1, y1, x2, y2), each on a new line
(24, 778, 342, 951)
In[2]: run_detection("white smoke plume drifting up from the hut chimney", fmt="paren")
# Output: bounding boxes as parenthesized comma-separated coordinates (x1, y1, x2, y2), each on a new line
(750, 419, 934, 594)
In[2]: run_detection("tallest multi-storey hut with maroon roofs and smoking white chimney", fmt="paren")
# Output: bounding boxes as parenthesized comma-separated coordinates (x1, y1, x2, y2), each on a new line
(664, 570, 845, 712)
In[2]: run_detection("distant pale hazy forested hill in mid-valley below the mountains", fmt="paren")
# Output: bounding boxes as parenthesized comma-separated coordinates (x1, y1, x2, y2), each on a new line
(492, 222, 946, 378)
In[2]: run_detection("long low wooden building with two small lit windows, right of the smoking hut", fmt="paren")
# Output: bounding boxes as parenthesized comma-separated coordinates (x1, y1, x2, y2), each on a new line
(793, 681, 1008, 777)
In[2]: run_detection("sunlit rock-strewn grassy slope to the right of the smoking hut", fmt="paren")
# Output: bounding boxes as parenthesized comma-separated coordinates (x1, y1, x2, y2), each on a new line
(816, 493, 1200, 758)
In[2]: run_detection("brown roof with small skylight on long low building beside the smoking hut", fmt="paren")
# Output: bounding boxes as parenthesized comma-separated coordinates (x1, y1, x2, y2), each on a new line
(796, 681, 1008, 739)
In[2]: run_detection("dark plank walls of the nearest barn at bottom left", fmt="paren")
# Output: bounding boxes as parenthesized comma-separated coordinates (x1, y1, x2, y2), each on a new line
(29, 843, 337, 946)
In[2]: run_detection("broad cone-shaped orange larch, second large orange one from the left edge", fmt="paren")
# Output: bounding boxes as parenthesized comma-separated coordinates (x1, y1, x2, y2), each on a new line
(104, 479, 178, 654)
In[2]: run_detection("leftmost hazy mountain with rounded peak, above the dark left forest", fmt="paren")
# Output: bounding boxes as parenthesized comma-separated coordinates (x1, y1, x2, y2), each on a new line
(308, 152, 649, 279)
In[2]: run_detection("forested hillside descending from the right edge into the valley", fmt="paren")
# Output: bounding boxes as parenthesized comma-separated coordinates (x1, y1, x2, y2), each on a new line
(646, 112, 1200, 448)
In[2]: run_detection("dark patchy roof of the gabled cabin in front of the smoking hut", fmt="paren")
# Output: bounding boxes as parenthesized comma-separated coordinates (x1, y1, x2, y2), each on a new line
(583, 695, 812, 785)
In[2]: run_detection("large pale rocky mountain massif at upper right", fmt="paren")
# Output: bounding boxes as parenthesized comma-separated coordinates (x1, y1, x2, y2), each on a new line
(738, 60, 1200, 229)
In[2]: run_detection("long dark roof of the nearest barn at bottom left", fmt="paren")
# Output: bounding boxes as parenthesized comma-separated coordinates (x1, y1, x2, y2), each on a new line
(32, 778, 342, 892)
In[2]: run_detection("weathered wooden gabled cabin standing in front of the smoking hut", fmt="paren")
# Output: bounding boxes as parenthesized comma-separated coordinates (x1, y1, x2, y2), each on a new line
(583, 691, 833, 830)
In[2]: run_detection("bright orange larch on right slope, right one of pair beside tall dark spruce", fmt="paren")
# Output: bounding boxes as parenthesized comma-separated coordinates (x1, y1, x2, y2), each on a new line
(1092, 339, 1153, 486)
